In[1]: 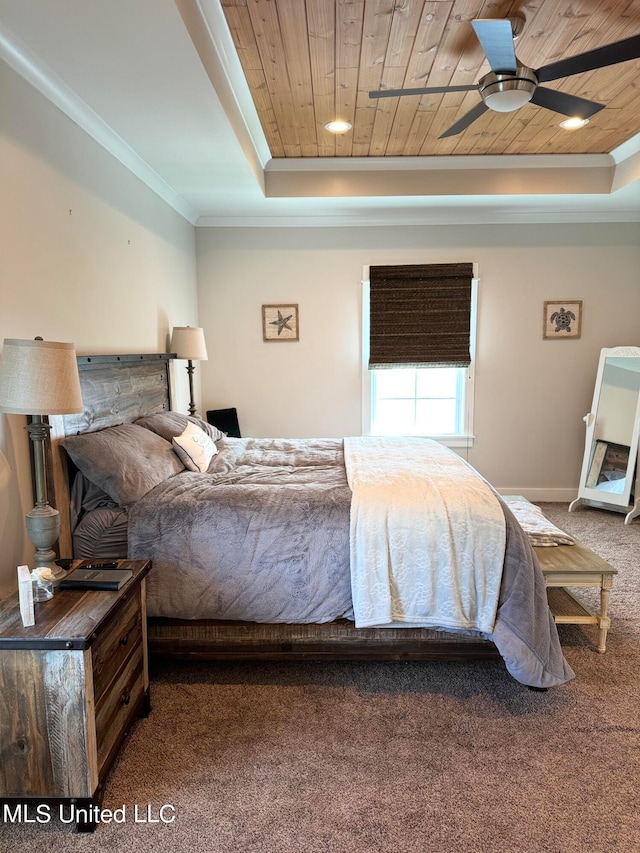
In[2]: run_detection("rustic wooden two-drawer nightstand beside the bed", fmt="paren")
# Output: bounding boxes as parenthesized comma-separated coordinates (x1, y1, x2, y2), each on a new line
(0, 560, 151, 831)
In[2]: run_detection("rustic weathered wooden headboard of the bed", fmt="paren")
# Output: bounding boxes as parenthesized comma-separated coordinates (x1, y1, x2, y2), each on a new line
(47, 353, 175, 557)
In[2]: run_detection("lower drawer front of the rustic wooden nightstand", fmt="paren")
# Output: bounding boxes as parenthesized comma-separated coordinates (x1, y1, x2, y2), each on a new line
(96, 642, 145, 771)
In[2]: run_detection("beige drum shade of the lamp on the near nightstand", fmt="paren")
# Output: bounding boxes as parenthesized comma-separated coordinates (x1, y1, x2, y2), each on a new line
(0, 338, 84, 415)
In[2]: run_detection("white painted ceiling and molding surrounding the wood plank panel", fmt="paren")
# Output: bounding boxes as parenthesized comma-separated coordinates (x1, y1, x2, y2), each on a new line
(0, 0, 640, 226)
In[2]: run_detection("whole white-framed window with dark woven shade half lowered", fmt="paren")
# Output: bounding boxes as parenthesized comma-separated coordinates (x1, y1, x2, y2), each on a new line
(363, 264, 477, 446)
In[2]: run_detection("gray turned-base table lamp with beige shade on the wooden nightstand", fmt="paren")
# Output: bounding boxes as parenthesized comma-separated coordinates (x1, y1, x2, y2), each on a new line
(0, 338, 84, 576)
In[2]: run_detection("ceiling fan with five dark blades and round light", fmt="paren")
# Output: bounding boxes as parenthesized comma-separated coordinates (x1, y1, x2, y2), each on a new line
(369, 18, 640, 139)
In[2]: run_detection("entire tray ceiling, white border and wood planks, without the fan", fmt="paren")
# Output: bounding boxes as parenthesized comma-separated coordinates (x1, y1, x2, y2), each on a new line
(0, 0, 640, 226)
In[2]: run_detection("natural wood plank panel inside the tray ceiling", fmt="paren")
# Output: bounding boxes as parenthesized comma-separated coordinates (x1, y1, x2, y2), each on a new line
(221, 0, 640, 158)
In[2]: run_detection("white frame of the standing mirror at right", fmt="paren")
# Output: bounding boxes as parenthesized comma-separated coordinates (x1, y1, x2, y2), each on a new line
(569, 347, 640, 524)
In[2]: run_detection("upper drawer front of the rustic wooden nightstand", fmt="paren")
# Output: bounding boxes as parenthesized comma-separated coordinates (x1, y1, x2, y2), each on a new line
(92, 589, 142, 706)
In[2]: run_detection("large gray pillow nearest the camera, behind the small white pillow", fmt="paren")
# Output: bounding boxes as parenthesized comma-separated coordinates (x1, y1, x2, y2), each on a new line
(62, 424, 184, 506)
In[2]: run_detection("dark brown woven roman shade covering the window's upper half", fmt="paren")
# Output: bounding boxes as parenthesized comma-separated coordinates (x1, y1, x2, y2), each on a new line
(369, 263, 473, 369)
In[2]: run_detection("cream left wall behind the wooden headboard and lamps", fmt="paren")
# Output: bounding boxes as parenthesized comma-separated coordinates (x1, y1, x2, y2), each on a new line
(0, 62, 198, 591)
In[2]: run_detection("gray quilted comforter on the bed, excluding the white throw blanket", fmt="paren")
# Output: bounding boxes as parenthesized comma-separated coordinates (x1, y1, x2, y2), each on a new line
(129, 439, 573, 687)
